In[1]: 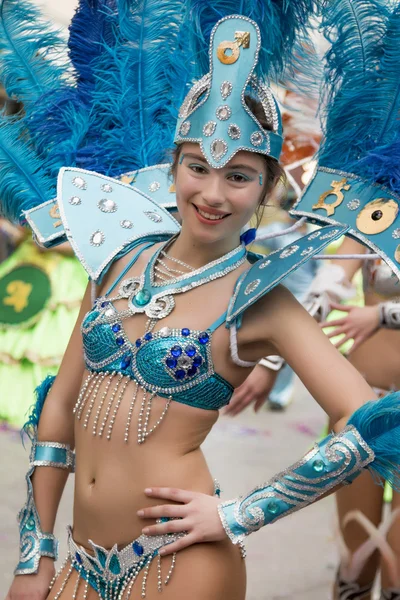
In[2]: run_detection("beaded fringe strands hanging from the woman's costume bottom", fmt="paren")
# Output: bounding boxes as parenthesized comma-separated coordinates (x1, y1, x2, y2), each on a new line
(49, 552, 176, 600)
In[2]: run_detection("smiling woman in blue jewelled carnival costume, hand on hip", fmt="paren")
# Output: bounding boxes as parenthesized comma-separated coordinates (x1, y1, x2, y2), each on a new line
(3, 1, 400, 600)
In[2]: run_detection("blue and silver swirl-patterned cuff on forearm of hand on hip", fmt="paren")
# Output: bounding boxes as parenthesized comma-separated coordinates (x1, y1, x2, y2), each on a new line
(218, 425, 375, 544)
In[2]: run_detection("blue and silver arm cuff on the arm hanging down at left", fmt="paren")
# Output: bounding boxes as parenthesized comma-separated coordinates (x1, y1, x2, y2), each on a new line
(14, 440, 75, 575)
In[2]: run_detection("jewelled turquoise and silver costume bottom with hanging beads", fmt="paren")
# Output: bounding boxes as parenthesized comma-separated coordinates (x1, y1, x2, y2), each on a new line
(48, 518, 186, 600)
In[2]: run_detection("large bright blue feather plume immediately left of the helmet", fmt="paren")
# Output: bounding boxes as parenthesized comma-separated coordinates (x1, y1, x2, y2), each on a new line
(77, 0, 192, 175)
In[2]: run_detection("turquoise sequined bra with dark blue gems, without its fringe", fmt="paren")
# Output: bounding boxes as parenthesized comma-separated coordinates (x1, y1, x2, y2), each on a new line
(82, 298, 233, 410)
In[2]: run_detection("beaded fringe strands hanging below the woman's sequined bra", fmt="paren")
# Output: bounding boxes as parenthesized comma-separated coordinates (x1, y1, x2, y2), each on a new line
(73, 371, 172, 444)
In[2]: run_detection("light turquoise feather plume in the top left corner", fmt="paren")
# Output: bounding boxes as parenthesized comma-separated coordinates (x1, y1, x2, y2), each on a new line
(0, 0, 68, 113)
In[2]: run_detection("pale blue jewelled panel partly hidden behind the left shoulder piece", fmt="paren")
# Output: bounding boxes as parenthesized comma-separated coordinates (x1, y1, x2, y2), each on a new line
(24, 163, 176, 248)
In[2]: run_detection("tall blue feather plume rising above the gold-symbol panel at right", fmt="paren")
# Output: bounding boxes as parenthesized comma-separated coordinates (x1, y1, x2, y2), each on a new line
(319, 3, 400, 190)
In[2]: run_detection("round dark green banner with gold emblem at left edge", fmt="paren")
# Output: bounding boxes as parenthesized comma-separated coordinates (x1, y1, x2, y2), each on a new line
(0, 265, 51, 326)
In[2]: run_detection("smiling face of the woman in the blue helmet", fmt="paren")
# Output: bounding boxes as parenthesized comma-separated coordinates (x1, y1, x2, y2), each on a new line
(175, 143, 266, 243)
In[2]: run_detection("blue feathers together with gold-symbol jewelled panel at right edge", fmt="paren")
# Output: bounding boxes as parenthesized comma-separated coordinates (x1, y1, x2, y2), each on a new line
(291, 0, 400, 277)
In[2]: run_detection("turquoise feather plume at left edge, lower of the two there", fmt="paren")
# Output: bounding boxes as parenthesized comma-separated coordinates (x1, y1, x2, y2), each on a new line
(0, 117, 55, 221)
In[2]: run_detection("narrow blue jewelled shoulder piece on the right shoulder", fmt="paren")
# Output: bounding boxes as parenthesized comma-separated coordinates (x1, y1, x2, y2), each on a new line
(226, 226, 348, 327)
